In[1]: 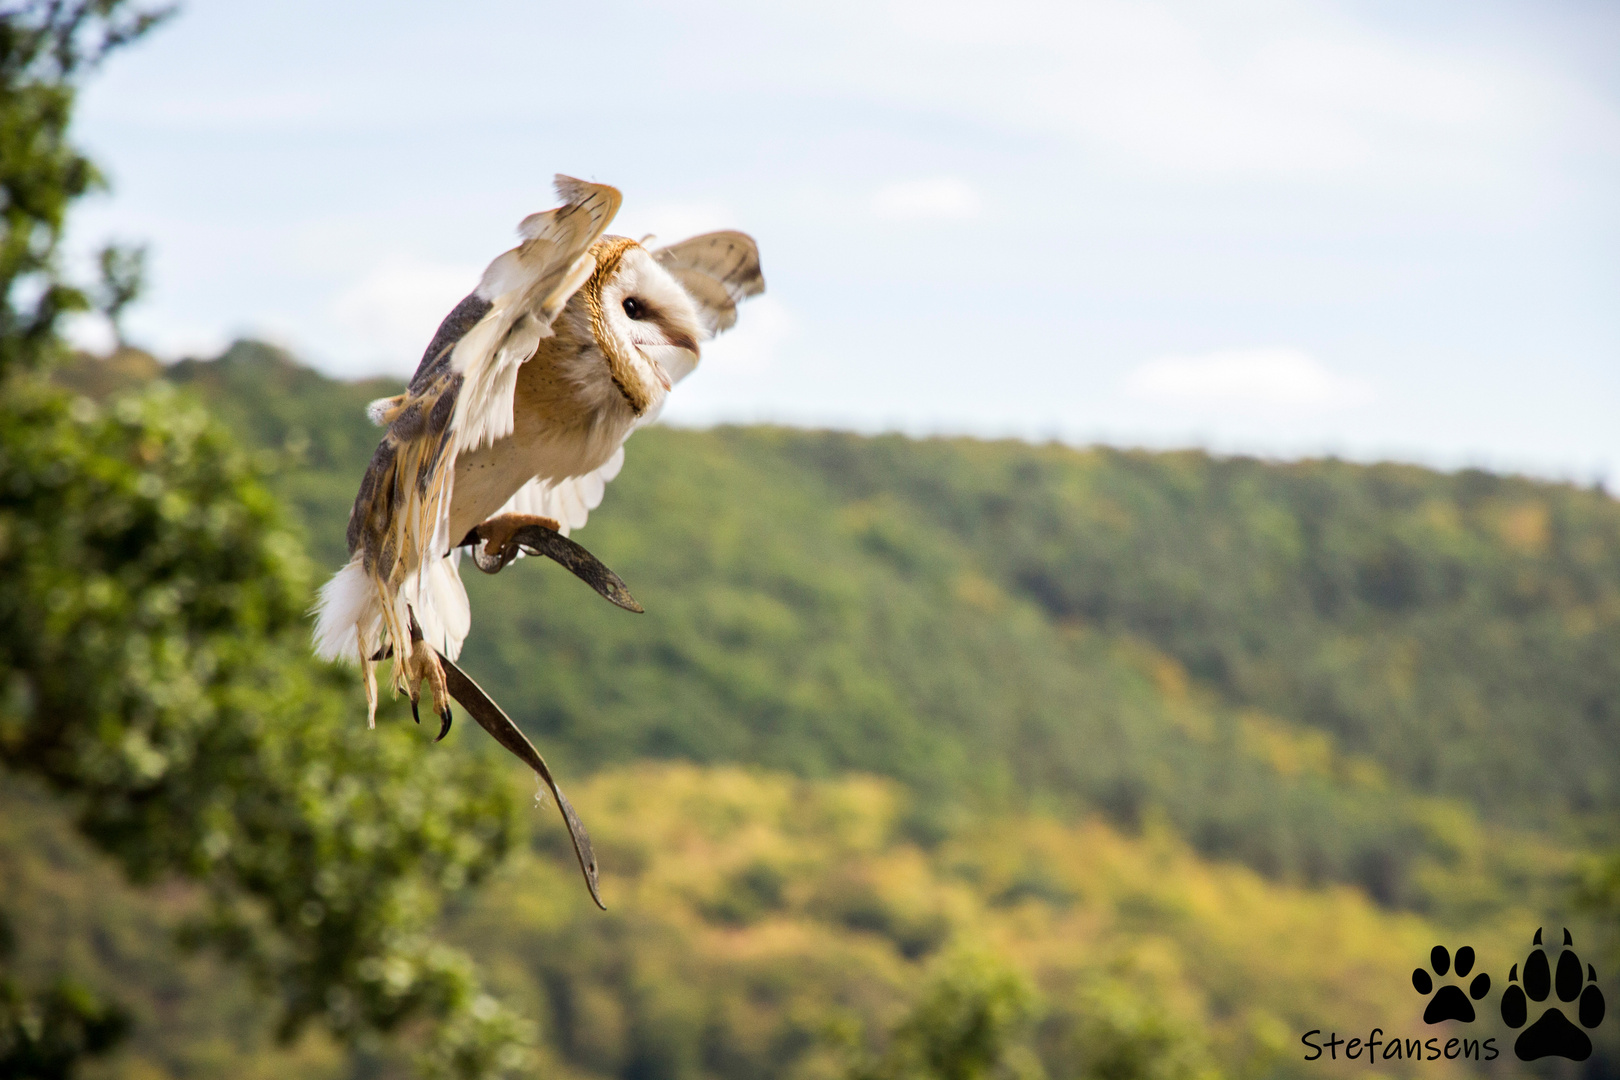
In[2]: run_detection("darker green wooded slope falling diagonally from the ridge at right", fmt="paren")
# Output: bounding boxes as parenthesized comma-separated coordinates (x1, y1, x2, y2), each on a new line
(764, 432, 1620, 823)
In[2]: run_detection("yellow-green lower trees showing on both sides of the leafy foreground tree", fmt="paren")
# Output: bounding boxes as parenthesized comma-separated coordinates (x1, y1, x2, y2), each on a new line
(0, 751, 1584, 1080)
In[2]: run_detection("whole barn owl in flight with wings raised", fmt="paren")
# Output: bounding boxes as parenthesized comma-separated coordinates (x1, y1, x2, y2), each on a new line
(314, 175, 765, 737)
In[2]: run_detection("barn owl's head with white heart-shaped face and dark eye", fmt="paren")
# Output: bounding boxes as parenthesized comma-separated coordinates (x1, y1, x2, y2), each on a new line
(580, 236, 706, 416)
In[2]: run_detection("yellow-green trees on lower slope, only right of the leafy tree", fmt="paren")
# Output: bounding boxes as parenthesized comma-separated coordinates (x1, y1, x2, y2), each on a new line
(455, 764, 1523, 1080)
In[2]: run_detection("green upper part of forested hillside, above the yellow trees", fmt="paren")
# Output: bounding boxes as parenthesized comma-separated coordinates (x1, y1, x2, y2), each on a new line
(85, 345, 1620, 910)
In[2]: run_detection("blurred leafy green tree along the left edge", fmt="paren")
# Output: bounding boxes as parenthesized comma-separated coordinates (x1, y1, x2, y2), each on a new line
(0, 0, 522, 1077)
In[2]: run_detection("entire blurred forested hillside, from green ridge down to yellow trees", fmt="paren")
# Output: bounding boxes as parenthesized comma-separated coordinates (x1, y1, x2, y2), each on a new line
(28, 343, 1620, 1080)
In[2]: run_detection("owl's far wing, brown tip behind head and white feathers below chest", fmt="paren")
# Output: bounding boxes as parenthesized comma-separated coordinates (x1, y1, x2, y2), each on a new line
(501, 232, 765, 536)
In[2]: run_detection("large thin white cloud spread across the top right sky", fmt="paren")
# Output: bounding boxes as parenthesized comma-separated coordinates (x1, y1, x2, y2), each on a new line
(838, 0, 1615, 183)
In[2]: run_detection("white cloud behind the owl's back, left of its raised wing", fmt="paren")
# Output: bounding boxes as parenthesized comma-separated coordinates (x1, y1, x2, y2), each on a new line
(330, 259, 481, 374)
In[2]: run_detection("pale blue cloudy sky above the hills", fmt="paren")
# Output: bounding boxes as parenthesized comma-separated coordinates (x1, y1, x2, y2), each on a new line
(70, 0, 1620, 486)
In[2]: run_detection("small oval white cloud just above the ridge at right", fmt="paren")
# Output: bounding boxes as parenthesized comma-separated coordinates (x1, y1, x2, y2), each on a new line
(1124, 348, 1372, 411)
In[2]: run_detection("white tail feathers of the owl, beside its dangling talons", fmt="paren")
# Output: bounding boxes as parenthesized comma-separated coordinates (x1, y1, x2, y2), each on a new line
(313, 551, 473, 725)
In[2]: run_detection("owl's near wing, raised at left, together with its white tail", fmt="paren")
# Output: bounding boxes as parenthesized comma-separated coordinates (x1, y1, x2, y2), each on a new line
(316, 175, 620, 711)
